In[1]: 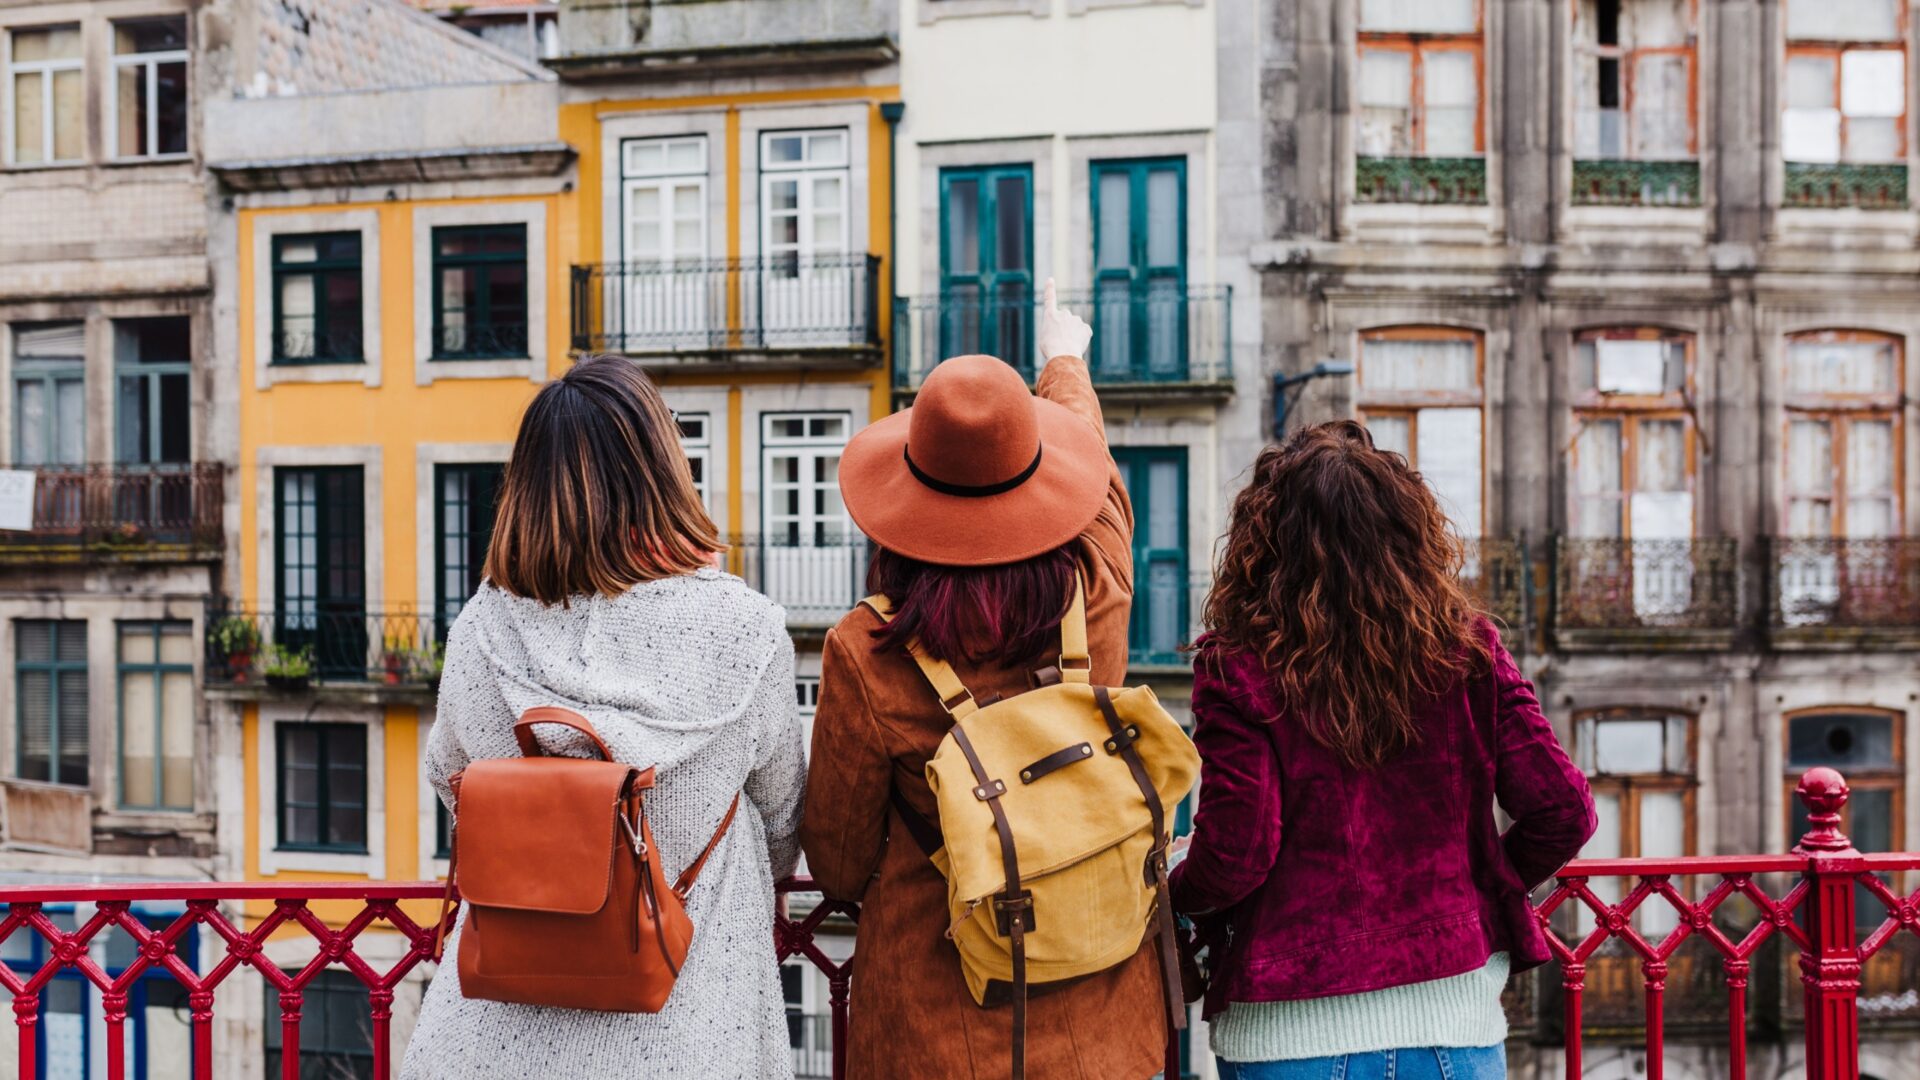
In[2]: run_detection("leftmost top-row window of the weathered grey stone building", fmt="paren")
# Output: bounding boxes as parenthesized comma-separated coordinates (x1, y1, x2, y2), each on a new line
(1356, 0, 1484, 158)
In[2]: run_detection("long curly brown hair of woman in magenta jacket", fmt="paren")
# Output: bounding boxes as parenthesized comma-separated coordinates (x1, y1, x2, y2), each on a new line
(1204, 421, 1490, 769)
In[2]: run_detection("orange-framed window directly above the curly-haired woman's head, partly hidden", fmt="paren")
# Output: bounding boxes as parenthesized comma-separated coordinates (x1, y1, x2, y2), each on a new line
(1357, 327, 1486, 538)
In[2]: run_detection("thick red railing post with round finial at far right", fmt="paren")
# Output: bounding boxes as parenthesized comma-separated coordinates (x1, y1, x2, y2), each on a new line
(1793, 769, 1862, 1080)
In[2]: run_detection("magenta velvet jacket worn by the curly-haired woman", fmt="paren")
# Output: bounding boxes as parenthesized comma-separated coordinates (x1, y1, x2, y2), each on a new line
(1173, 623, 1594, 1017)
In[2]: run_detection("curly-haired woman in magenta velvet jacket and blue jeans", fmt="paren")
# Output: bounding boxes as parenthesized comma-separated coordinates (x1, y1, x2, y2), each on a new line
(1173, 421, 1594, 1080)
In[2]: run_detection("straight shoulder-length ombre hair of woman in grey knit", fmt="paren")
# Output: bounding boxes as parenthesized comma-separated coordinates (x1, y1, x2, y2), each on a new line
(486, 356, 726, 603)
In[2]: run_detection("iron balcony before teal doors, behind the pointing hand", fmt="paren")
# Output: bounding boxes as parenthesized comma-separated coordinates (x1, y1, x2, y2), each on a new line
(893, 284, 1233, 400)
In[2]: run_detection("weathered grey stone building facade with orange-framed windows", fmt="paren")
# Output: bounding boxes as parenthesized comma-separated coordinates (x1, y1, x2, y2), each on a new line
(1251, 0, 1920, 1080)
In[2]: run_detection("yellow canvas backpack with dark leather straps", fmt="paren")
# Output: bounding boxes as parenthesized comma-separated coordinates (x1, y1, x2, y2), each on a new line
(864, 580, 1200, 1080)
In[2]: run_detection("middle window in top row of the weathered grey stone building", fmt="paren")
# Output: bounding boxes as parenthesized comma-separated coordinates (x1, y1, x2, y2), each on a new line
(1574, 0, 1695, 161)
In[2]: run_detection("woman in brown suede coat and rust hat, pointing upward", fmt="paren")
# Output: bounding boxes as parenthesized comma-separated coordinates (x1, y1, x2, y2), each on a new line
(801, 281, 1165, 1080)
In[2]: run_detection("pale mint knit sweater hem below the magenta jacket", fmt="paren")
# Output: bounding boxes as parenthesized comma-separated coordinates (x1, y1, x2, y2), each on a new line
(1208, 953, 1509, 1063)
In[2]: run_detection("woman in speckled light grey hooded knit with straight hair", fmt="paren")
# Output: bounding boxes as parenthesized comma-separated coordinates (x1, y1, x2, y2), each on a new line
(401, 357, 806, 1080)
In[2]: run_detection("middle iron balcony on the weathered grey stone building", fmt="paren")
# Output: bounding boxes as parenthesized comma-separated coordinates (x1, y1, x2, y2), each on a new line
(1553, 536, 1740, 650)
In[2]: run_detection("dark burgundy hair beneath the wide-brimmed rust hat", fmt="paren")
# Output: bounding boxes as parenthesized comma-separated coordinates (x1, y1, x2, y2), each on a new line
(866, 548, 1077, 667)
